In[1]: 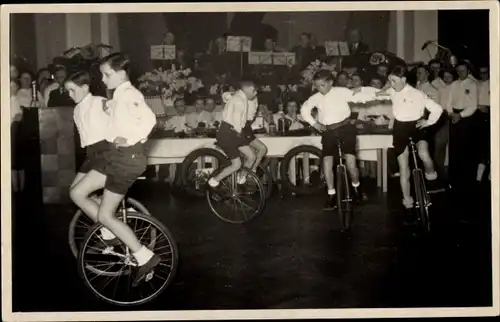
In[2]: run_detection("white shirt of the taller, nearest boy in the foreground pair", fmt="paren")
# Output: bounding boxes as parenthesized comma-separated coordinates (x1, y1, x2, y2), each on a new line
(106, 82, 156, 145)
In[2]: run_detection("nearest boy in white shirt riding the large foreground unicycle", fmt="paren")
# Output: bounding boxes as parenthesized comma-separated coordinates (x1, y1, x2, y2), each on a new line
(71, 53, 161, 286)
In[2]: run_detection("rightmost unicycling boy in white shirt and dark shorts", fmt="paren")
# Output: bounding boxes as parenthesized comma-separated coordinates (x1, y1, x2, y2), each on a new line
(385, 66, 443, 216)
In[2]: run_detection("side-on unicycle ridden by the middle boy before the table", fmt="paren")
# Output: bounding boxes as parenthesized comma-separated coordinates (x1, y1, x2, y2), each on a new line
(206, 168, 266, 224)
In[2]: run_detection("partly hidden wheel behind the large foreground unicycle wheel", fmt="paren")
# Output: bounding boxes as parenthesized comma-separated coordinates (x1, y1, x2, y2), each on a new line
(68, 198, 150, 258)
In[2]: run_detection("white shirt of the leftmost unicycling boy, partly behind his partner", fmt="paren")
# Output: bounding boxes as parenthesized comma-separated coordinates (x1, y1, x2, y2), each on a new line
(73, 94, 111, 148)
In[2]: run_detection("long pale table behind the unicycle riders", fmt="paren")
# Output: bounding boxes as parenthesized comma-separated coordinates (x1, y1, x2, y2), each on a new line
(146, 135, 392, 192)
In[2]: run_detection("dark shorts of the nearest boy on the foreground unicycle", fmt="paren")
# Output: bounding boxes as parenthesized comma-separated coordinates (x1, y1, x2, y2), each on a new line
(94, 143, 148, 195)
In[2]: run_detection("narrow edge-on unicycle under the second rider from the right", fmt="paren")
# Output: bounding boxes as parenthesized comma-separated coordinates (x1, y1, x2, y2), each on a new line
(335, 139, 353, 232)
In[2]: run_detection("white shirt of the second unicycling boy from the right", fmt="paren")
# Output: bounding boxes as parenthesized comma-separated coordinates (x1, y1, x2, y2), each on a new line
(300, 87, 353, 125)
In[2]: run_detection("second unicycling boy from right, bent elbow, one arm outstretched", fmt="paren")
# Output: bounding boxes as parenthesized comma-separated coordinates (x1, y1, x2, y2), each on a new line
(300, 70, 361, 210)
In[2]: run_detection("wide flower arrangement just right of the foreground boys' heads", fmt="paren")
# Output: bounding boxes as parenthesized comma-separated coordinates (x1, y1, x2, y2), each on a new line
(138, 68, 204, 101)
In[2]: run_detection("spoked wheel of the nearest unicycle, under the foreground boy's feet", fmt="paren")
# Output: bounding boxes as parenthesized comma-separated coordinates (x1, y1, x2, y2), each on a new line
(77, 213, 179, 306)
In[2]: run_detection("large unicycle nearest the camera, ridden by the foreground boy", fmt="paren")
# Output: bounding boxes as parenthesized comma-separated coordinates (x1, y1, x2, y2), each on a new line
(78, 199, 178, 306)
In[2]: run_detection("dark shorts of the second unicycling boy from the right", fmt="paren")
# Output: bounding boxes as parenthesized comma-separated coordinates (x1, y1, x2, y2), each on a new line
(321, 122, 357, 157)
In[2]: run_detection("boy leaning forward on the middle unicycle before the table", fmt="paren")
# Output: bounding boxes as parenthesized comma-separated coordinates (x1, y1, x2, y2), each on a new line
(208, 79, 257, 189)
